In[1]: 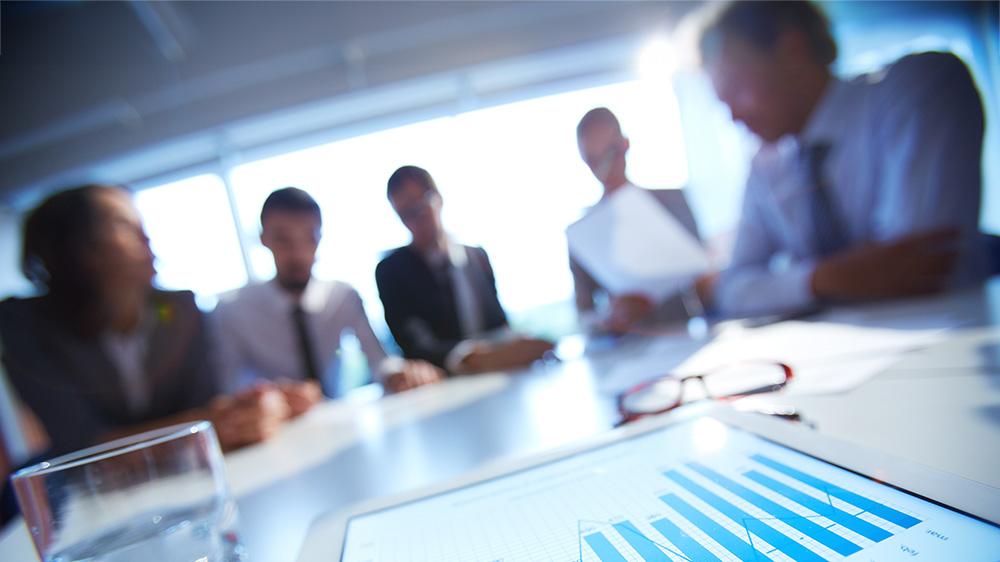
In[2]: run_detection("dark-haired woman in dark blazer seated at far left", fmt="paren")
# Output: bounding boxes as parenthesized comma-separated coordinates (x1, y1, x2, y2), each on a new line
(0, 185, 289, 454)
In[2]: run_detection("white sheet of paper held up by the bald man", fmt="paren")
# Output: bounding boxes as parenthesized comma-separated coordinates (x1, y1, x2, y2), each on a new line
(566, 186, 709, 301)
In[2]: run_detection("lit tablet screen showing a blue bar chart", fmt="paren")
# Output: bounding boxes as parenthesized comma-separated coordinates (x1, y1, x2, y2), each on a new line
(342, 418, 1000, 562)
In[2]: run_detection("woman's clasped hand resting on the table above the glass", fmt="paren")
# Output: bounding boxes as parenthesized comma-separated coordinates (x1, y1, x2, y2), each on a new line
(208, 384, 291, 451)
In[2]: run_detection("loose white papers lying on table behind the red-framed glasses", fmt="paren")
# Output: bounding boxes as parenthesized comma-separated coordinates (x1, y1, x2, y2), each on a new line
(600, 321, 945, 394)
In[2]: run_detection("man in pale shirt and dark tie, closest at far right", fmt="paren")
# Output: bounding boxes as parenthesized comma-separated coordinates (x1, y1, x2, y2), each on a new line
(700, 2, 991, 316)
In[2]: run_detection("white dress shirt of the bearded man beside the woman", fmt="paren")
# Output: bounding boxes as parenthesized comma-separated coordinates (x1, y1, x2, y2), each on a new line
(212, 279, 399, 392)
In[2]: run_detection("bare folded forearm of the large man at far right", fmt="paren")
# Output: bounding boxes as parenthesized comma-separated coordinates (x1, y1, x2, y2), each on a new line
(812, 229, 958, 301)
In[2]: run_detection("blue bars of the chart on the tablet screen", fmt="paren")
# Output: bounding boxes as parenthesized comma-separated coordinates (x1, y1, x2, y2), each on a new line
(581, 455, 921, 562)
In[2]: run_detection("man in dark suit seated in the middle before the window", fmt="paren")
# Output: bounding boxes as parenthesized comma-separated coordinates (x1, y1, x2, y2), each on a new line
(375, 166, 552, 373)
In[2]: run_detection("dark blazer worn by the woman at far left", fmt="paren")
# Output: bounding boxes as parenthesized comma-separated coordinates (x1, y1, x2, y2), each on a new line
(0, 291, 219, 454)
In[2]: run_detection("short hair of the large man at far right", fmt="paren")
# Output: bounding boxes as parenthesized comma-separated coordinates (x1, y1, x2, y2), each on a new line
(698, 0, 837, 65)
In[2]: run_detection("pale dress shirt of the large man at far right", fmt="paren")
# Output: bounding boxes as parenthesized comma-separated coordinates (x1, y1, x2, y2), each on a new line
(716, 53, 988, 316)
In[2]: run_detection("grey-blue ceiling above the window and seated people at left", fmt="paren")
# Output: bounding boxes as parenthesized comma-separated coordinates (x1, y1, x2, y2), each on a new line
(0, 1, 696, 203)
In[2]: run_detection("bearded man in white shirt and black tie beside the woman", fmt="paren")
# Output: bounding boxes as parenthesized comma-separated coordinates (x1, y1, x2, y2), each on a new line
(214, 187, 442, 402)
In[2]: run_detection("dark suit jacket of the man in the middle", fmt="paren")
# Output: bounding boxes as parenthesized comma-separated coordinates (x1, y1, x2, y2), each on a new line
(375, 246, 507, 367)
